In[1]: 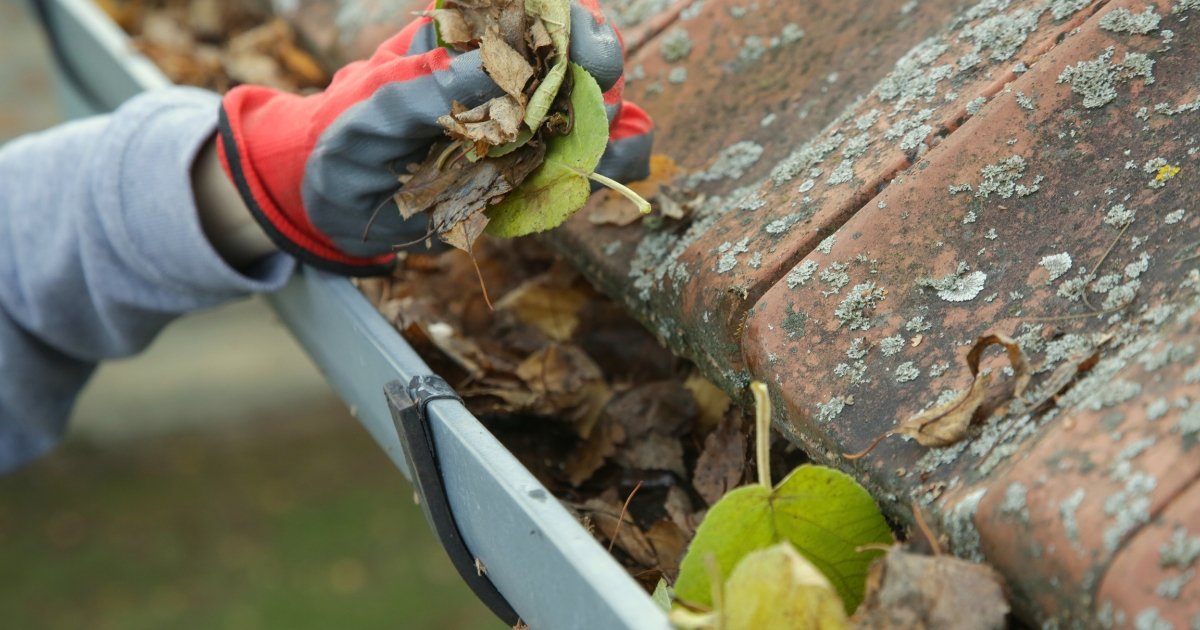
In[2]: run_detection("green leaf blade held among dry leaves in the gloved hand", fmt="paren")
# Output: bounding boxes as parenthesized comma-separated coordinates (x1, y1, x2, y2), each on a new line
(487, 64, 608, 238)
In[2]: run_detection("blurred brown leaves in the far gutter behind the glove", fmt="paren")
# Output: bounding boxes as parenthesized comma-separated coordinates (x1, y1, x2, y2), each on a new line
(96, 0, 330, 92)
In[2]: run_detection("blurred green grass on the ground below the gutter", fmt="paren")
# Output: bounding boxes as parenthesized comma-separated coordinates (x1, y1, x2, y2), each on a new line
(0, 408, 504, 630)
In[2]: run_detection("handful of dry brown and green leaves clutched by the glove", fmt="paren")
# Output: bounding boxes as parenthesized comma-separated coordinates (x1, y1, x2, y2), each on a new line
(395, 0, 649, 252)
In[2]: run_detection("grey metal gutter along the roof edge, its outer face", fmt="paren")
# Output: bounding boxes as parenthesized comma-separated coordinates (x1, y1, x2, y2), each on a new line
(37, 0, 670, 630)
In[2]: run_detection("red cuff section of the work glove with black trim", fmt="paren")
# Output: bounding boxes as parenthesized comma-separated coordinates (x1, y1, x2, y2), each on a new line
(217, 85, 396, 276)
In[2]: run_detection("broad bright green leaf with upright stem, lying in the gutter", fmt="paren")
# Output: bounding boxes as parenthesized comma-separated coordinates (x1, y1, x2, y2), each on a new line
(676, 464, 893, 613)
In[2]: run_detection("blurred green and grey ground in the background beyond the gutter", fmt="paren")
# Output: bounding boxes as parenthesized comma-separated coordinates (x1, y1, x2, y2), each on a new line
(0, 1, 503, 630)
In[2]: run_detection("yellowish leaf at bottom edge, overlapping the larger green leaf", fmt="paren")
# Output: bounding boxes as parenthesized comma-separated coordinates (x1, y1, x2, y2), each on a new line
(720, 541, 850, 630)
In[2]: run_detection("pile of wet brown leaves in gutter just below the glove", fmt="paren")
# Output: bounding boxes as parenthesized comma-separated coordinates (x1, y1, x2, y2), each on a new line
(358, 239, 804, 589)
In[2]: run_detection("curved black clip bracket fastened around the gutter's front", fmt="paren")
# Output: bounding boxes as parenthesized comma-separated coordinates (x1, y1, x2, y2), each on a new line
(383, 374, 520, 626)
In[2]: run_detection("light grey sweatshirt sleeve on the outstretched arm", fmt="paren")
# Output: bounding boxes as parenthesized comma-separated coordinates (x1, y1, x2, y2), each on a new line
(0, 88, 295, 473)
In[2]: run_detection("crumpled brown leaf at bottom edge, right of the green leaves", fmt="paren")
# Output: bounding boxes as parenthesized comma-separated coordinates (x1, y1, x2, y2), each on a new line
(853, 547, 1009, 630)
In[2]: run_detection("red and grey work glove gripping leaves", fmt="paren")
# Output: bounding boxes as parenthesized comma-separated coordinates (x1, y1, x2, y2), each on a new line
(217, 0, 653, 276)
